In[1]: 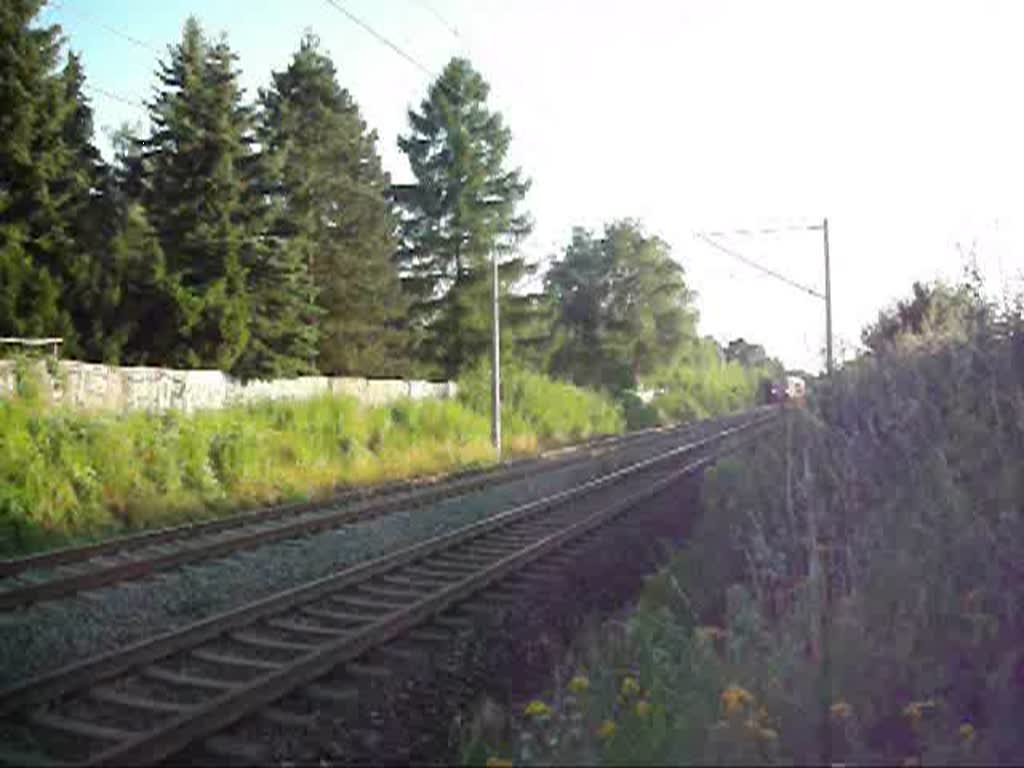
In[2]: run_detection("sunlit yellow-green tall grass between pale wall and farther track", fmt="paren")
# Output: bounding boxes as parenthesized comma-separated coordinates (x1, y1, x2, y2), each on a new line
(0, 371, 623, 553)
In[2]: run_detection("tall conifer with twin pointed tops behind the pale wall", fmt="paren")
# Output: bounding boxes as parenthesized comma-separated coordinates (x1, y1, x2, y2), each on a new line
(143, 18, 257, 370)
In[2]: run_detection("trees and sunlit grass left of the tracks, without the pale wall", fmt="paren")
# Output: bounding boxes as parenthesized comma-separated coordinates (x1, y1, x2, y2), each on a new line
(0, 0, 780, 547)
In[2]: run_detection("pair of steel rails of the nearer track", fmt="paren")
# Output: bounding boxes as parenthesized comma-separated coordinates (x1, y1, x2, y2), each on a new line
(0, 413, 773, 765)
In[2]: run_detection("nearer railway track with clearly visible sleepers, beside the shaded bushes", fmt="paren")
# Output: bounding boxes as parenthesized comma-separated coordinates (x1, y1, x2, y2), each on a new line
(0, 411, 774, 765)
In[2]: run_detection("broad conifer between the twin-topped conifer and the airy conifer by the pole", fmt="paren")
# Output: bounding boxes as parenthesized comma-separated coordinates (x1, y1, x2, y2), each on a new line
(261, 35, 406, 376)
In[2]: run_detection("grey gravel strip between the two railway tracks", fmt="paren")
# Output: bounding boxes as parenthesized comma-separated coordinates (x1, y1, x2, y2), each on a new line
(0, 446, 653, 685)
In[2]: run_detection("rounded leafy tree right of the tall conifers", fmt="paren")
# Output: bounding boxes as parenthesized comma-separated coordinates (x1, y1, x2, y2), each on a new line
(547, 220, 696, 392)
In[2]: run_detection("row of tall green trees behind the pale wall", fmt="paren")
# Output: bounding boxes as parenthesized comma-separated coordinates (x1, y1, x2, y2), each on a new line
(0, 0, 778, 403)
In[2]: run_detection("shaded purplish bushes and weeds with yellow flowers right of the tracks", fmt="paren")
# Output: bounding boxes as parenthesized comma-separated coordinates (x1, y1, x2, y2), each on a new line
(479, 282, 1024, 765)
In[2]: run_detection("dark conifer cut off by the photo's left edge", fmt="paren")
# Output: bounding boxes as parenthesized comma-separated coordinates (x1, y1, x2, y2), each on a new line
(0, 0, 103, 353)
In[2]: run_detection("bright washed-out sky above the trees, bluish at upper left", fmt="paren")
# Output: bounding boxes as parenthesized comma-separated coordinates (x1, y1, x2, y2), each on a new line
(46, 0, 1024, 370)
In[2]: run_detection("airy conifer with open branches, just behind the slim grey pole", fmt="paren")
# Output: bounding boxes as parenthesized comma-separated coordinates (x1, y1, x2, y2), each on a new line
(398, 58, 530, 377)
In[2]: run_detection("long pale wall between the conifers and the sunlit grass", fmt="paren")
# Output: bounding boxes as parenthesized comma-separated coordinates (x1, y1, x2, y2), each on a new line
(0, 360, 456, 413)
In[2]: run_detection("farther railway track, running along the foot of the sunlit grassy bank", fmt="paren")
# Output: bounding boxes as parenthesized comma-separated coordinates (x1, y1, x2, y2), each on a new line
(0, 415, 749, 611)
